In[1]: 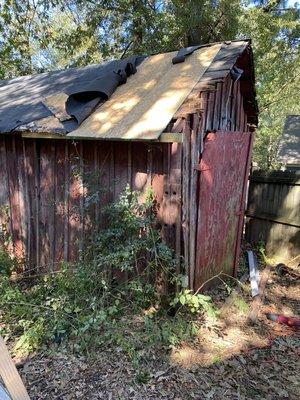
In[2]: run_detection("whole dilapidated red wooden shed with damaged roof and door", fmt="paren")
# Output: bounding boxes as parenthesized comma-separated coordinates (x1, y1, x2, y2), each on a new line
(0, 40, 257, 289)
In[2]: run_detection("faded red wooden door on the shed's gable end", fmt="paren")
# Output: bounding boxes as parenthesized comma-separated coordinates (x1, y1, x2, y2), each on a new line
(193, 131, 252, 290)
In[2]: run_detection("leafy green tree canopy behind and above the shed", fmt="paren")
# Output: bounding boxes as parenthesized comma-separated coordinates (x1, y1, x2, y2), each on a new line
(0, 0, 300, 168)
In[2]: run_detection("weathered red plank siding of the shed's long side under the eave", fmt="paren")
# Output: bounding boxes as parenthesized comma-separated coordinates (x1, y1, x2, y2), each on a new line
(0, 135, 181, 271)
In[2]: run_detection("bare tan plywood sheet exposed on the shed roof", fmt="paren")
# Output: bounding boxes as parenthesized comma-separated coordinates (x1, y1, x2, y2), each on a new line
(67, 44, 221, 140)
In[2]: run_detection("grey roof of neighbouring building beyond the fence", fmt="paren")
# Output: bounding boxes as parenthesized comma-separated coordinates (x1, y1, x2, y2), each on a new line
(278, 115, 300, 165)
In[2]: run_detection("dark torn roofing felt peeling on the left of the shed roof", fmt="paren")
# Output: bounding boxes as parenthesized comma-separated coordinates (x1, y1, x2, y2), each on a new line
(0, 56, 144, 134)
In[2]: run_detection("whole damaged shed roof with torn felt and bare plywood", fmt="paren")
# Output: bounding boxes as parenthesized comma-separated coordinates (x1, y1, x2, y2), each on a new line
(0, 40, 255, 140)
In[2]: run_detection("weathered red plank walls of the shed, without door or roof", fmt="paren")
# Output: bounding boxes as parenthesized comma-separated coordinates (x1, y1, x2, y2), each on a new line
(0, 75, 248, 274)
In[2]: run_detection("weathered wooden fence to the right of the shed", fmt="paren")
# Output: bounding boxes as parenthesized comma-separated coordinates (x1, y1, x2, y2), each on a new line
(246, 171, 300, 263)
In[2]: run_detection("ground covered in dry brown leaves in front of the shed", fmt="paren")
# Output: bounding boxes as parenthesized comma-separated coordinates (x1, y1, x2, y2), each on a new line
(16, 260, 300, 400)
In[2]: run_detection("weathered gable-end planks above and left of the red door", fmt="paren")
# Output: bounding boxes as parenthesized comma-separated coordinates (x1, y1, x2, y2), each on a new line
(175, 75, 251, 288)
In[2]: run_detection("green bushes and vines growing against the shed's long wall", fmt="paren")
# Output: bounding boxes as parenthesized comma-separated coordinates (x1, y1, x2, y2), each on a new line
(0, 188, 211, 360)
